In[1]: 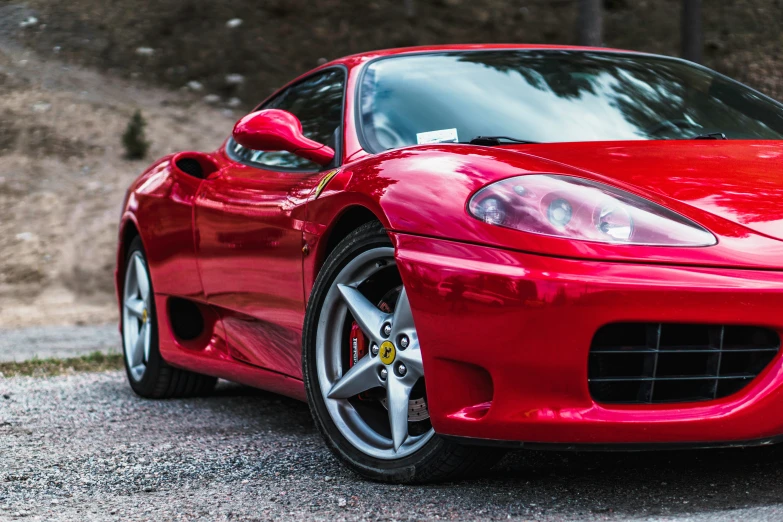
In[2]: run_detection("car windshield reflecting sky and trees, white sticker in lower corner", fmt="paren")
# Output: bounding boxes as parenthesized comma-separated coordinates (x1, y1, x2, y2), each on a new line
(359, 50, 783, 152)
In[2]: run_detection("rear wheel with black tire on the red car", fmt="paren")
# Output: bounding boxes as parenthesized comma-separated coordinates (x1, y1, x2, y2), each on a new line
(120, 236, 217, 399)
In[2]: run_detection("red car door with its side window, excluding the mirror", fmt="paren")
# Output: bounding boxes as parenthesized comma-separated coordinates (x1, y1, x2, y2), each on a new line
(194, 68, 345, 378)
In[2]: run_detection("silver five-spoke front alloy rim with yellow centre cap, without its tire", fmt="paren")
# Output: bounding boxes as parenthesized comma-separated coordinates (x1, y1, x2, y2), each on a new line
(316, 247, 434, 459)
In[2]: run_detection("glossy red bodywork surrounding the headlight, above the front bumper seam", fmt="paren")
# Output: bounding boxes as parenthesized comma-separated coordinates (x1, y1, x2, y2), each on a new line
(308, 145, 783, 269)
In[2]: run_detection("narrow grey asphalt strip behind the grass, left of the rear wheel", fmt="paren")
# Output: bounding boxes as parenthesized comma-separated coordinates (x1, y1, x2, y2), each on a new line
(0, 323, 122, 362)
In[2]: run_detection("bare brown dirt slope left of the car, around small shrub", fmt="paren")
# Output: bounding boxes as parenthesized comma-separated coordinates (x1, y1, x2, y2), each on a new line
(0, 40, 231, 328)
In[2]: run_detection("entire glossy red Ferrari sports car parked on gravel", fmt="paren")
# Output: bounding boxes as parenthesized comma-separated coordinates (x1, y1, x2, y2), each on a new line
(116, 45, 783, 482)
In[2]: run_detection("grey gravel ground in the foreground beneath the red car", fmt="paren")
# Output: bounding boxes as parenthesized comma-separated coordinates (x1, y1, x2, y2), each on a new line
(0, 372, 783, 520)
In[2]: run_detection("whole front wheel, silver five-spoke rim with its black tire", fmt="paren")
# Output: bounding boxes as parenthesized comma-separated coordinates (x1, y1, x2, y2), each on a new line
(302, 222, 500, 483)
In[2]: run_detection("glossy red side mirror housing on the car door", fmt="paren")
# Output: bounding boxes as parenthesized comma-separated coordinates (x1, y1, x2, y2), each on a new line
(233, 109, 334, 166)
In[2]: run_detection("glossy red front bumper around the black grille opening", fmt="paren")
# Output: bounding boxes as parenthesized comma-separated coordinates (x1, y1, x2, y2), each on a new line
(394, 234, 783, 445)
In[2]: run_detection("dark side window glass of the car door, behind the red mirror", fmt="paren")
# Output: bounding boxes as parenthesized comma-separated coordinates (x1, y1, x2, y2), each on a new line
(227, 69, 345, 171)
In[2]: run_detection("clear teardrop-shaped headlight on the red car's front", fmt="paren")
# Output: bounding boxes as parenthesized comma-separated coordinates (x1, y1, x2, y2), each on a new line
(468, 174, 717, 247)
